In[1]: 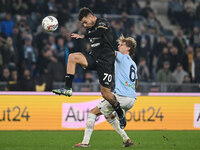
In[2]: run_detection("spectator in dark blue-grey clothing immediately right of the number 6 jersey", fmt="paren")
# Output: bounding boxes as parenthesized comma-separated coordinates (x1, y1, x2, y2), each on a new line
(138, 58, 150, 82)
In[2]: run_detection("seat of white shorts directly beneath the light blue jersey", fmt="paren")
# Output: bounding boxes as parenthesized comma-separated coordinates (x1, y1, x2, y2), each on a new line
(114, 94, 135, 111)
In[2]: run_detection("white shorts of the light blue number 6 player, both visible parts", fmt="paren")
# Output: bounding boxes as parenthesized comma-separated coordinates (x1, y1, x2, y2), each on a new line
(97, 94, 135, 117)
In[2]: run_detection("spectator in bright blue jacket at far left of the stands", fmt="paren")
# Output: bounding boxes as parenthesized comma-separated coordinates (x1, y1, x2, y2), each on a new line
(1, 13, 14, 37)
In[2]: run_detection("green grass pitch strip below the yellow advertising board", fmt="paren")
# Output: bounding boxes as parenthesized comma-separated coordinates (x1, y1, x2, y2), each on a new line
(0, 131, 200, 150)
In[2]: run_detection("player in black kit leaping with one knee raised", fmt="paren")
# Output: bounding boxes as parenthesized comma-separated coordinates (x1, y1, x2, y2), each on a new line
(53, 7, 126, 129)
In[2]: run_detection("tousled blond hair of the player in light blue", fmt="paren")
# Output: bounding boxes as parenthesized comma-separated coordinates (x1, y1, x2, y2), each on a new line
(117, 35, 137, 57)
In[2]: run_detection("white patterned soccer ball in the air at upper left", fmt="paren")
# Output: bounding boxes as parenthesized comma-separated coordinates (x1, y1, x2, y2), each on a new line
(42, 16, 58, 32)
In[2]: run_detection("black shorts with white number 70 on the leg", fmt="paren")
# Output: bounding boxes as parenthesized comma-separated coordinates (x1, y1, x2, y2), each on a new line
(83, 53, 115, 88)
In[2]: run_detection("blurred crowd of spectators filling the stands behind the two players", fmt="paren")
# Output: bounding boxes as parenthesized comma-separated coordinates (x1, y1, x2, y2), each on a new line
(0, 0, 200, 91)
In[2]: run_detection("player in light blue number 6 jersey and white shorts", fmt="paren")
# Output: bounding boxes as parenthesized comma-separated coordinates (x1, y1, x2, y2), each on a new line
(74, 35, 138, 147)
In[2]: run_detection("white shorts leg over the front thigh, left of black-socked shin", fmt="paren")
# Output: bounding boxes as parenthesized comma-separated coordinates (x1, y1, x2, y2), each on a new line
(97, 100, 114, 118)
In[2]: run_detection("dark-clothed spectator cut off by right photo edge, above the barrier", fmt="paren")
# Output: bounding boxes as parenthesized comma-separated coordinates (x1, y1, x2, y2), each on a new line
(191, 51, 200, 83)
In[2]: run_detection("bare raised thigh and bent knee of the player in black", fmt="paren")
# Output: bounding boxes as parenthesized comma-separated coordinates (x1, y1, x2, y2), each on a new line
(69, 52, 88, 68)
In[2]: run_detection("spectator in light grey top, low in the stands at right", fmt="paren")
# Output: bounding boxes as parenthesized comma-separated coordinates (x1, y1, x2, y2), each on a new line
(172, 62, 188, 84)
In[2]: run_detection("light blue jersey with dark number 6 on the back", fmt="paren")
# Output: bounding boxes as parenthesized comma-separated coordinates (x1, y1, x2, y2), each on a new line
(114, 52, 138, 99)
